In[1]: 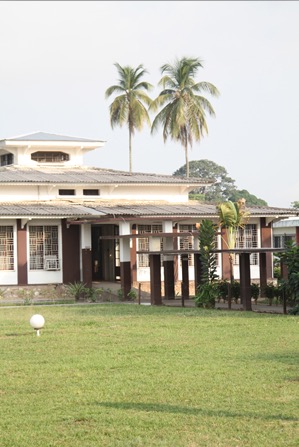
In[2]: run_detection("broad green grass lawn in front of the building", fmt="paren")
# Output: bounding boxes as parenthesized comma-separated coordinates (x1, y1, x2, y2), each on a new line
(0, 304, 299, 447)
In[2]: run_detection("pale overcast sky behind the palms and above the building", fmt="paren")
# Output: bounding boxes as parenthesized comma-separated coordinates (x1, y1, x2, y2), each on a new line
(0, 1, 299, 207)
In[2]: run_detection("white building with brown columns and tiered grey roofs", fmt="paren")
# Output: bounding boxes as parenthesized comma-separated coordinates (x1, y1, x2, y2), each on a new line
(0, 132, 296, 300)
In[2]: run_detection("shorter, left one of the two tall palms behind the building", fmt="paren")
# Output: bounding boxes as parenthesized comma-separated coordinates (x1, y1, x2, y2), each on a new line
(105, 63, 152, 174)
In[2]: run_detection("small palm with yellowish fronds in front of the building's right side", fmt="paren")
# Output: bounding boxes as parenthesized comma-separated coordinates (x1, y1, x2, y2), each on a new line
(217, 199, 250, 309)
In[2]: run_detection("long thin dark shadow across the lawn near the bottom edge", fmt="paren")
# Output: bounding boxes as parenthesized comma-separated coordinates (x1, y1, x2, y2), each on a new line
(97, 402, 299, 422)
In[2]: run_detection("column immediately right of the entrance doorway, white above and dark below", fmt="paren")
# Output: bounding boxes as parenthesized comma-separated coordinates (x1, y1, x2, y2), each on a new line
(119, 222, 132, 299)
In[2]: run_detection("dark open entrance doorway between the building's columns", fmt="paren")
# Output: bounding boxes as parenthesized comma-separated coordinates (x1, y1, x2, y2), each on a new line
(91, 225, 120, 282)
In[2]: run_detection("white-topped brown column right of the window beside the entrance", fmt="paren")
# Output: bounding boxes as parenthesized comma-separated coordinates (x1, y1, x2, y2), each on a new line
(162, 221, 175, 300)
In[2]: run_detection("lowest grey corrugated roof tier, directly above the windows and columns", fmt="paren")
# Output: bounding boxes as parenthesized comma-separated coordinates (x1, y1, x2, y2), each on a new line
(0, 200, 298, 220)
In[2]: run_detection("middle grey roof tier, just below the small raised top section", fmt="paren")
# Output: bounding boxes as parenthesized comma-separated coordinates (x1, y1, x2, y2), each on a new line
(0, 166, 213, 186)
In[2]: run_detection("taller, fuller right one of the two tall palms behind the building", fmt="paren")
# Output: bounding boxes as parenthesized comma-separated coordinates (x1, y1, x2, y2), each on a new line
(151, 57, 219, 177)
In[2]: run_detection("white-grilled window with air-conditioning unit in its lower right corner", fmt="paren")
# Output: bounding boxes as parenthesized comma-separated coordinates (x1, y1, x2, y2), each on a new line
(29, 225, 60, 270)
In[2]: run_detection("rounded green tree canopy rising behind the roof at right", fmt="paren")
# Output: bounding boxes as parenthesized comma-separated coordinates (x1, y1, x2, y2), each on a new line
(173, 160, 267, 206)
